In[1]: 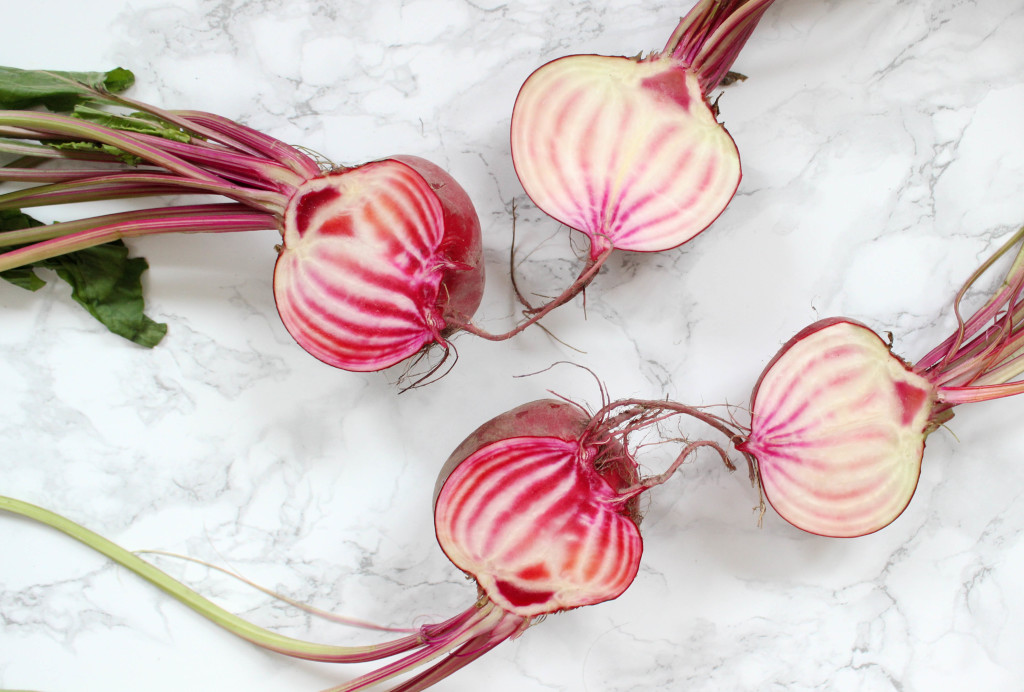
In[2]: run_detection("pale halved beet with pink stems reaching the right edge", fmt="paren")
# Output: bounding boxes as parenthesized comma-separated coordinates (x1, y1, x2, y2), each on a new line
(737, 228, 1024, 536)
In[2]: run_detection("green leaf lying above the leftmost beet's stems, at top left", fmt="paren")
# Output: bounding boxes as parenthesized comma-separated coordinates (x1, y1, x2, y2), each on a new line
(0, 67, 135, 113)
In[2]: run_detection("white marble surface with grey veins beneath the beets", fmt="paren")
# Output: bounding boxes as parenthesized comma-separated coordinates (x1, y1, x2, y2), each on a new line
(0, 0, 1024, 692)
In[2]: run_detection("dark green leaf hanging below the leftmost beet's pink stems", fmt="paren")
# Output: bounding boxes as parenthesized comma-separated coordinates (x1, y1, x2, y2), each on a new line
(0, 209, 167, 348)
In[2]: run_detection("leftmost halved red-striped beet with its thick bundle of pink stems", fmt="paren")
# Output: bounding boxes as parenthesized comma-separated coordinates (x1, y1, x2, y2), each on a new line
(0, 69, 483, 372)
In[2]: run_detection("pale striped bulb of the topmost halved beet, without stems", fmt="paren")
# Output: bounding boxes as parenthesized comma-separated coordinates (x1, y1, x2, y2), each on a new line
(512, 55, 739, 258)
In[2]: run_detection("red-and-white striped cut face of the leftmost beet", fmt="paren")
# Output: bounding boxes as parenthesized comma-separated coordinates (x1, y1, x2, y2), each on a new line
(273, 161, 444, 371)
